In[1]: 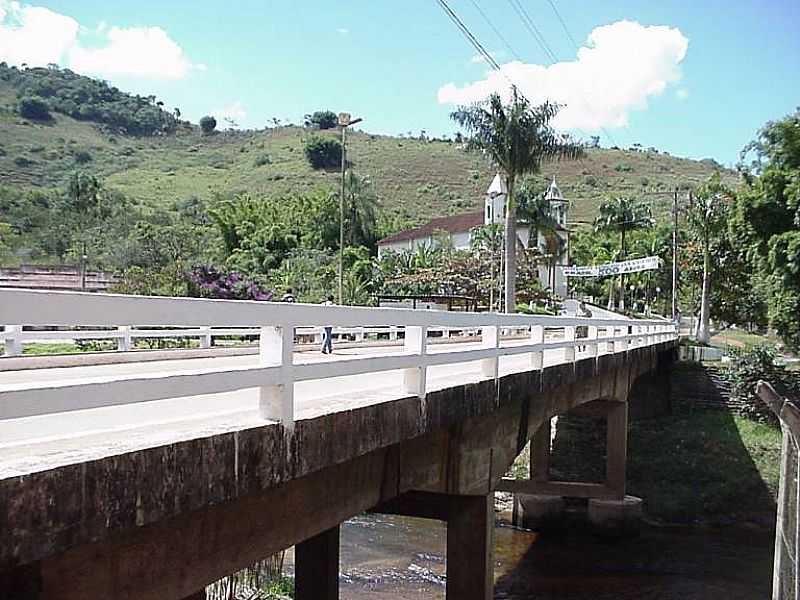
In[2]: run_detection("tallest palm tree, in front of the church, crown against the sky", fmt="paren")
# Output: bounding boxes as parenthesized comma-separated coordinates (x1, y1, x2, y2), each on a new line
(451, 87, 583, 312)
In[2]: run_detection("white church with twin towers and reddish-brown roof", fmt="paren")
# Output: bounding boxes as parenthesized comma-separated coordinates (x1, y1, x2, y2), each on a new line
(378, 173, 569, 298)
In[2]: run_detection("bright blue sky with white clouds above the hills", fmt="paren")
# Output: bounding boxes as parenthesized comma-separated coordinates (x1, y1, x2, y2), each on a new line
(0, 0, 800, 165)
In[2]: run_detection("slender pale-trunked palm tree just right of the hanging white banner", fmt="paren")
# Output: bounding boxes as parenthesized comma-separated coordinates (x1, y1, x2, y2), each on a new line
(689, 173, 730, 344)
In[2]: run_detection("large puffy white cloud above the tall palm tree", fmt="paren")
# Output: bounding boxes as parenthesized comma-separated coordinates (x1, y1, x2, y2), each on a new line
(438, 21, 689, 130)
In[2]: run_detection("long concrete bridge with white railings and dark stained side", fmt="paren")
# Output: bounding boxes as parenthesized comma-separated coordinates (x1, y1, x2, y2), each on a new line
(0, 290, 676, 600)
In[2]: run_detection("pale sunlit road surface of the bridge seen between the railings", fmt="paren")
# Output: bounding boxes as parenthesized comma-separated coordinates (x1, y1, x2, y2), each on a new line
(0, 340, 605, 478)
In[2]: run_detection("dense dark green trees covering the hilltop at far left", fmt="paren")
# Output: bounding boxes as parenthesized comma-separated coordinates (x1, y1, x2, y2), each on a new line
(0, 63, 180, 135)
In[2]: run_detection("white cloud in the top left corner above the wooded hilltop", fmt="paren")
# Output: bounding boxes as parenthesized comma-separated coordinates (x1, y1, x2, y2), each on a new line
(0, 0, 200, 79)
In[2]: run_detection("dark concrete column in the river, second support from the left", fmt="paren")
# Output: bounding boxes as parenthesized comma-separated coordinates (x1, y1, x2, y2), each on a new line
(444, 494, 494, 600)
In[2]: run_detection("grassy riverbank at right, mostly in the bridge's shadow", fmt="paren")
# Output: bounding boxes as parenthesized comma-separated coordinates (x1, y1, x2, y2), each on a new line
(628, 411, 781, 523)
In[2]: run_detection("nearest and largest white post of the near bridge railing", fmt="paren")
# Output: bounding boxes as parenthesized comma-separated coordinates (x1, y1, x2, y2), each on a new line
(258, 325, 294, 431)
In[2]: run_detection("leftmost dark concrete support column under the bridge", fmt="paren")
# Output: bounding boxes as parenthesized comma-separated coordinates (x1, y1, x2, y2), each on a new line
(294, 525, 339, 600)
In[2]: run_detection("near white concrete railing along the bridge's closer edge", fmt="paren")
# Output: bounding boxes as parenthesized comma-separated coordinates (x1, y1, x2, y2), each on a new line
(0, 289, 677, 428)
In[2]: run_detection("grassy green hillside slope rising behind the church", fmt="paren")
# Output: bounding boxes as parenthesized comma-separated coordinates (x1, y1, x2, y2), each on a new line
(0, 81, 735, 227)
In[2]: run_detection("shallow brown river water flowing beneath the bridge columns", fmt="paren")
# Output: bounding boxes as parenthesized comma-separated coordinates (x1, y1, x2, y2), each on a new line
(288, 515, 773, 600)
